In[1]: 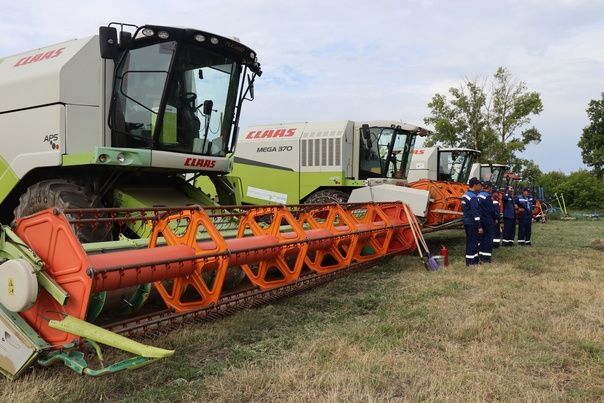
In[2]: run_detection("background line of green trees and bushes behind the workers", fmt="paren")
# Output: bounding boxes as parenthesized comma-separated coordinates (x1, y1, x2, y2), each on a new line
(424, 67, 604, 208)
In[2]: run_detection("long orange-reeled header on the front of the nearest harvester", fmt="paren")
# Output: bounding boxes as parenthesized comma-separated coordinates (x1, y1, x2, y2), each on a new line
(0, 203, 415, 377)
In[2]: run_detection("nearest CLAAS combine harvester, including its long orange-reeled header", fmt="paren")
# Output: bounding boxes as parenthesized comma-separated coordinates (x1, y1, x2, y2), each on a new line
(0, 24, 415, 378)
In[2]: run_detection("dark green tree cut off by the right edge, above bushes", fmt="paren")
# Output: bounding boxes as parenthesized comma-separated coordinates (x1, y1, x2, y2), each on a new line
(577, 93, 604, 179)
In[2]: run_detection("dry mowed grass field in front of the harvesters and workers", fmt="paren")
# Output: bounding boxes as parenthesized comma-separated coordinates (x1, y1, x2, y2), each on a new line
(0, 221, 604, 401)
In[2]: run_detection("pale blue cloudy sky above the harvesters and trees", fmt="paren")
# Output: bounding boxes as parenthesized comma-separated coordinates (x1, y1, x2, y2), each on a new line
(0, 0, 604, 172)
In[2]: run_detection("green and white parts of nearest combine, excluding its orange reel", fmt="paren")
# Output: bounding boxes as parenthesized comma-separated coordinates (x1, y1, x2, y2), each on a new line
(0, 23, 261, 377)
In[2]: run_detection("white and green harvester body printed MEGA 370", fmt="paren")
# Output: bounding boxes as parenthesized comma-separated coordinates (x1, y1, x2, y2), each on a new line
(232, 121, 429, 204)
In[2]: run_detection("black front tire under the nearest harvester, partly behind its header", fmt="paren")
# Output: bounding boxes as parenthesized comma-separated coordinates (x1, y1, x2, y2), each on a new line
(14, 179, 111, 243)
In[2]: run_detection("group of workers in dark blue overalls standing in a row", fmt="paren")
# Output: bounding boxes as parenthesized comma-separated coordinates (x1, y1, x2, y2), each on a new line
(461, 178, 535, 266)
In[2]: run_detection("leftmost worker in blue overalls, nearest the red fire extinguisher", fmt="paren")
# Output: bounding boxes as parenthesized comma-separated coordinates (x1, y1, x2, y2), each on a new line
(461, 178, 483, 266)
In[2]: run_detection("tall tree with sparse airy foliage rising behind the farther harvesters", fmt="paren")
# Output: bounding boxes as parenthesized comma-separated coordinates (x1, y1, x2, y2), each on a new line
(424, 67, 543, 164)
